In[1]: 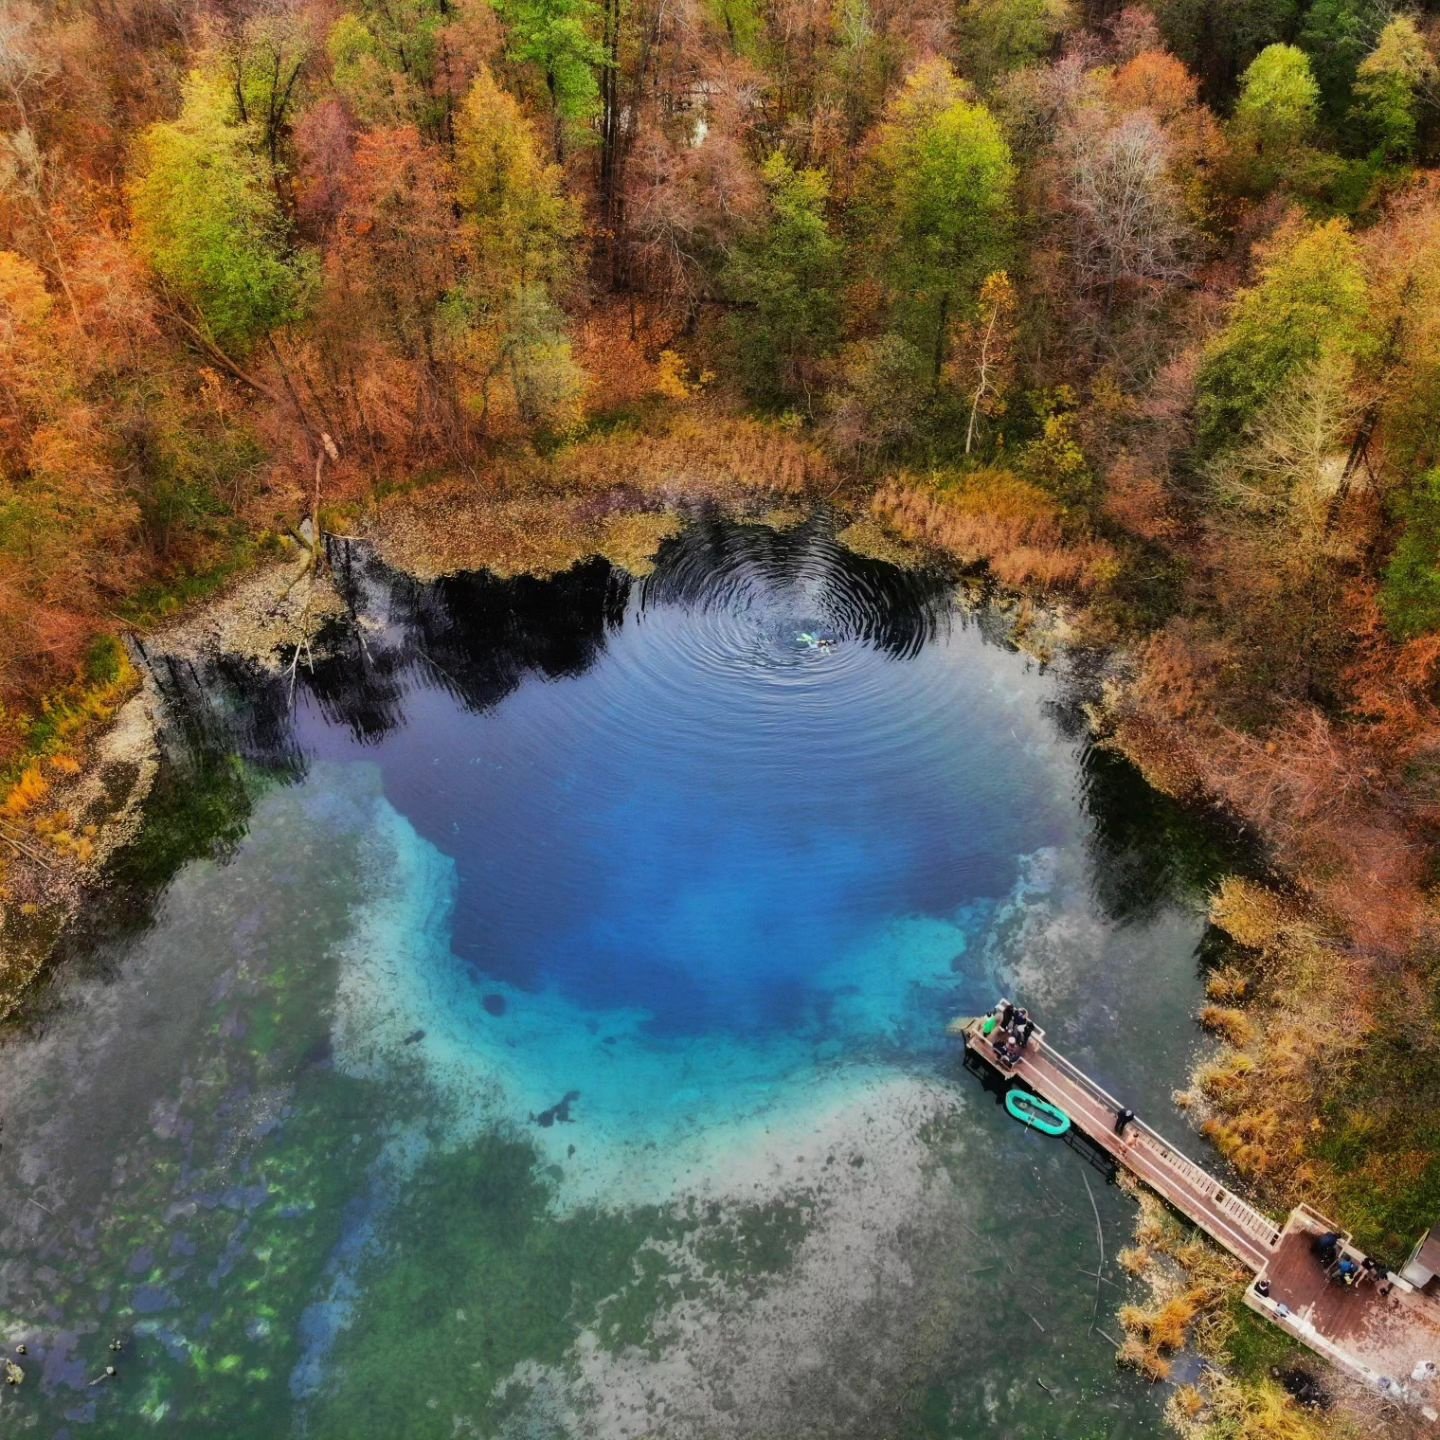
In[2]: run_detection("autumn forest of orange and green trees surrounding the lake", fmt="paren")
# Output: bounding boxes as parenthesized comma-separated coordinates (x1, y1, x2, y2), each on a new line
(0, 0, 1440, 1434)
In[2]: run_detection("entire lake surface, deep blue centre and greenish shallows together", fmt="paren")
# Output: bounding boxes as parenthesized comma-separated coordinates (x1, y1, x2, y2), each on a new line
(0, 518, 1238, 1440)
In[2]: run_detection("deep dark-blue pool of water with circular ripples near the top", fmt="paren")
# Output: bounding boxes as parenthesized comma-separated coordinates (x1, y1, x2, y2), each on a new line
(301, 530, 1073, 1037)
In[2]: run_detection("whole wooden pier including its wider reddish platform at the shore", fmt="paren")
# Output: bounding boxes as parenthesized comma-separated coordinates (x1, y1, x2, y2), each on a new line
(949, 1018, 1440, 1420)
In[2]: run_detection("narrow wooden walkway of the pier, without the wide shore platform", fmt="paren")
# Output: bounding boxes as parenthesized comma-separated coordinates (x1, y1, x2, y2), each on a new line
(950, 1020, 1282, 1274)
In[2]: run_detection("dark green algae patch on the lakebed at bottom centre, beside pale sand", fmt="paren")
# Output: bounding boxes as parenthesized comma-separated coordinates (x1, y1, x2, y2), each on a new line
(308, 1133, 808, 1440)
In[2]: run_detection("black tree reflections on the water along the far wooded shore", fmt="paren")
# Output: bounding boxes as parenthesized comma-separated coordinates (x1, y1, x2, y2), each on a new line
(135, 516, 1244, 950)
